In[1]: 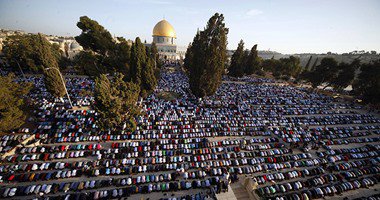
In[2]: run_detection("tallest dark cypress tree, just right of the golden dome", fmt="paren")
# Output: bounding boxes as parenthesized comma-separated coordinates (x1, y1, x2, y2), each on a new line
(185, 13, 228, 97)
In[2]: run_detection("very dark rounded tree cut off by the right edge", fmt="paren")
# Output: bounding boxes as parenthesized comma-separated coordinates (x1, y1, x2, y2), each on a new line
(352, 60, 380, 104)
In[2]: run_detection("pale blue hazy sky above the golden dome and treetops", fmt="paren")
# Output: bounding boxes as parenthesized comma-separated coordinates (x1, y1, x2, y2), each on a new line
(0, 0, 380, 53)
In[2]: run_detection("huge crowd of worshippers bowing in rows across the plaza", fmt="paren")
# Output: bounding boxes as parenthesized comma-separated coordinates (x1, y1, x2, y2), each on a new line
(0, 68, 380, 200)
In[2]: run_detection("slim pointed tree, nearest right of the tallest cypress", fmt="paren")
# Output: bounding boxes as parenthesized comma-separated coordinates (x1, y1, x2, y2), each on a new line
(229, 40, 246, 77)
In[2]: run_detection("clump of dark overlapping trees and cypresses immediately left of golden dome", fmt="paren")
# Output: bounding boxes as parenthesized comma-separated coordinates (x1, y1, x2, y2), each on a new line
(75, 16, 158, 96)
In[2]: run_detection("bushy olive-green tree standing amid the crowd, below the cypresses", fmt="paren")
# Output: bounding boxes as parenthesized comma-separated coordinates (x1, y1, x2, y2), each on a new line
(94, 73, 140, 131)
